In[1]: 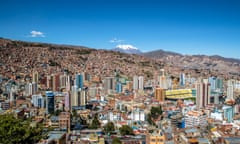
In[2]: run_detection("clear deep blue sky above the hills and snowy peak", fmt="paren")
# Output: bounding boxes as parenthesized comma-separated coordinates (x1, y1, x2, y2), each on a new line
(0, 0, 240, 58)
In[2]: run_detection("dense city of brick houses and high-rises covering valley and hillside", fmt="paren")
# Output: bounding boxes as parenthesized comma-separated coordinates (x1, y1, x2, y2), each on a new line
(0, 39, 240, 144)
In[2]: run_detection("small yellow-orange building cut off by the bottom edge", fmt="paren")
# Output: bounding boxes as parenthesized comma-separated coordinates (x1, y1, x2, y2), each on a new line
(148, 130, 165, 144)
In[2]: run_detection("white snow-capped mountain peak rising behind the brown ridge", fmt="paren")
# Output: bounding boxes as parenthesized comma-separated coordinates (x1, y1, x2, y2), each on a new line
(113, 45, 142, 54)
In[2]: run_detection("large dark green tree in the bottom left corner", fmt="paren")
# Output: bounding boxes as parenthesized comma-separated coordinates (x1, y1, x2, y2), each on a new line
(0, 114, 44, 144)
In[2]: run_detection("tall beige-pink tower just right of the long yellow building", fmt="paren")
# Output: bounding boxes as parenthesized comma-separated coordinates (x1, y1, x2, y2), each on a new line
(195, 79, 211, 110)
